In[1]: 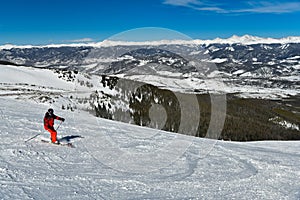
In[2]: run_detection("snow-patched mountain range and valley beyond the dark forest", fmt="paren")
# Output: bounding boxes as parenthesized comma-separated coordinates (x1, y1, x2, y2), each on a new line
(0, 35, 300, 97)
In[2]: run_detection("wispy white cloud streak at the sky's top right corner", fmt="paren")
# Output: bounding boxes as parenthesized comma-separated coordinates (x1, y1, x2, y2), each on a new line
(164, 0, 300, 14)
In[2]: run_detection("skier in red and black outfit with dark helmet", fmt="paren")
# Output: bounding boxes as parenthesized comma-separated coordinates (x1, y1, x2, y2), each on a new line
(44, 108, 65, 143)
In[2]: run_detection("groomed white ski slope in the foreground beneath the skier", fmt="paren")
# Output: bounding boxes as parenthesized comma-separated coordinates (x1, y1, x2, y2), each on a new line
(0, 98, 300, 200)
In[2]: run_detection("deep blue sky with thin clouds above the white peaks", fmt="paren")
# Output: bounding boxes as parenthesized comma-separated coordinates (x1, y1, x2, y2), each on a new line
(0, 0, 300, 44)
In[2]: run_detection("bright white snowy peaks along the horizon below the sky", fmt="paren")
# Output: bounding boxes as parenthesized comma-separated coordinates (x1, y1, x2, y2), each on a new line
(0, 35, 300, 50)
